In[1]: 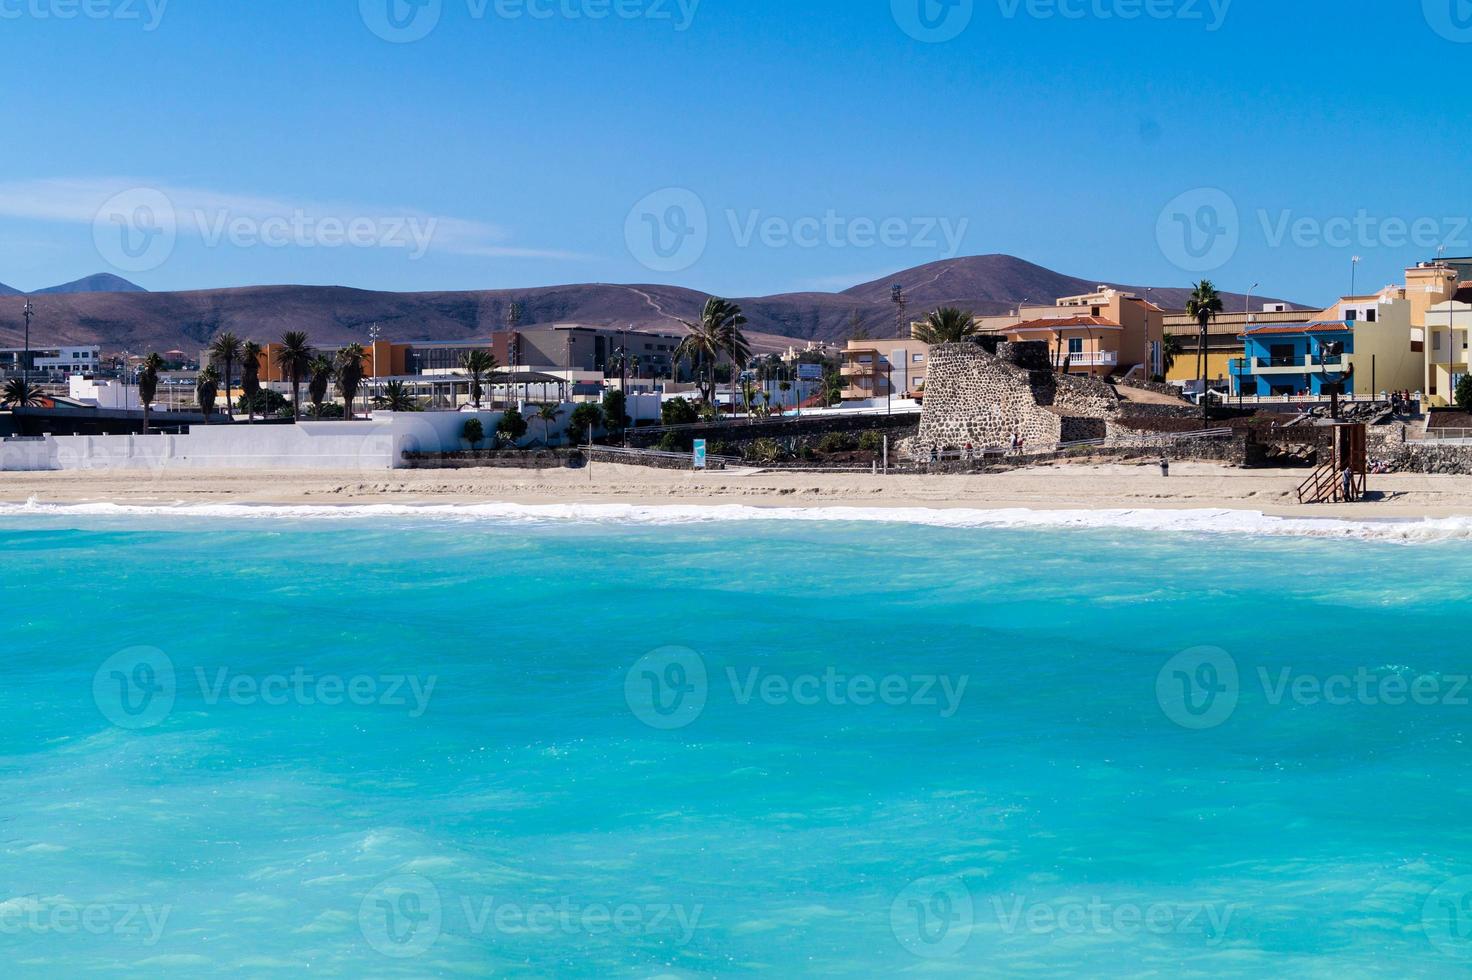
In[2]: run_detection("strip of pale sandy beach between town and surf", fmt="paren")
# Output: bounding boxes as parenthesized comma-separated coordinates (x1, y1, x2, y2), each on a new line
(0, 464, 1472, 519)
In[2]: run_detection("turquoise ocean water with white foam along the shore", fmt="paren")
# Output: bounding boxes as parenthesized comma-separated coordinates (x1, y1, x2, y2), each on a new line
(0, 508, 1472, 979)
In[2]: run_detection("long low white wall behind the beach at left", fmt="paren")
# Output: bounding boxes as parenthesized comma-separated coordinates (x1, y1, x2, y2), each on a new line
(0, 412, 524, 472)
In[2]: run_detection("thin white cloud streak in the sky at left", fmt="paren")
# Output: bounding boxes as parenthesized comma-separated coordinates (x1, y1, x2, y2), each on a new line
(0, 177, 593, 260)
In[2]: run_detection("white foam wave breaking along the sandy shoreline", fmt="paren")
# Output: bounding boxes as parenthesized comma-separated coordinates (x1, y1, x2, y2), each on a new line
(0, 500, 1472, 544)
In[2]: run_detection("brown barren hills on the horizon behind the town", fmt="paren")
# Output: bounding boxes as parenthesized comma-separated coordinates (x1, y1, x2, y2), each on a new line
(0, 256, 1313, 352)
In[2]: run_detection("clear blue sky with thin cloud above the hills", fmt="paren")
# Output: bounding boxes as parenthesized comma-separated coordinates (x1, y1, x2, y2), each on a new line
(0, 0, 1472, 303)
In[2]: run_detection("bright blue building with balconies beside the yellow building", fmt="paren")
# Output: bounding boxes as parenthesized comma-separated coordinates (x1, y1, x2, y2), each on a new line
(1231, 321, 1354, 397)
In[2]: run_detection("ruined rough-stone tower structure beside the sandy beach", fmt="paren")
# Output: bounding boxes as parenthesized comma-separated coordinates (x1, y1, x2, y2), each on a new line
(914, 343, 1120, 455)
